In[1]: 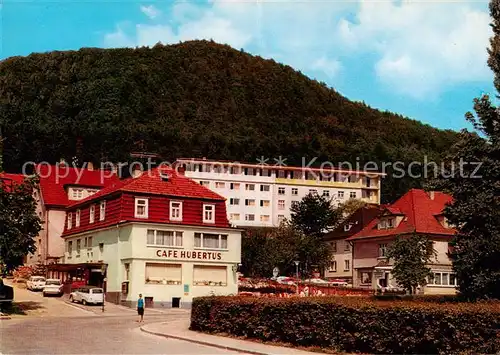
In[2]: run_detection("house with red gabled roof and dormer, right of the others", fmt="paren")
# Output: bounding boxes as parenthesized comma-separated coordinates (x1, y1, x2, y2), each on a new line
(346, 189, 457, 294)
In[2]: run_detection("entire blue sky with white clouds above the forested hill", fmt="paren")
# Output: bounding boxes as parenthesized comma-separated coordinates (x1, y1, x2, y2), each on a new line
(0, 0, 494, 130)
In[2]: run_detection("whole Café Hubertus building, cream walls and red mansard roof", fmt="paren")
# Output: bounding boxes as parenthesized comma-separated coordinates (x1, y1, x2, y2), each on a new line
(59, 168, 241, 308)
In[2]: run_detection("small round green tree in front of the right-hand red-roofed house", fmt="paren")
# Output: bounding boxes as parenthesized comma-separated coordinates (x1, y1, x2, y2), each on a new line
(387, 233, 436, 294)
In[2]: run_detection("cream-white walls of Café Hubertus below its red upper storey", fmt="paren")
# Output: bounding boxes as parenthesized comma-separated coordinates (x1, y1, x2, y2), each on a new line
(64, 223, 241, 308)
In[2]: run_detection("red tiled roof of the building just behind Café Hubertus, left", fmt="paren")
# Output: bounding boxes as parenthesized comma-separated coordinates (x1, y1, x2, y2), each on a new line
(36, 164, 119, 207)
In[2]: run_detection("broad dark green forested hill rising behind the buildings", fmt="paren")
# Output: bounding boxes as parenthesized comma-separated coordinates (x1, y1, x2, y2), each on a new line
(0, 41, 456, 203)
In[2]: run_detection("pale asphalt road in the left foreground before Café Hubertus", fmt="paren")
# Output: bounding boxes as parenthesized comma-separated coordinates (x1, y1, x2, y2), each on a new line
(0, 284, 246, 355)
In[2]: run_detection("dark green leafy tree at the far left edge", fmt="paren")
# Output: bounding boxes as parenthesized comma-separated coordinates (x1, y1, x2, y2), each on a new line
(0, 180, 42, 272)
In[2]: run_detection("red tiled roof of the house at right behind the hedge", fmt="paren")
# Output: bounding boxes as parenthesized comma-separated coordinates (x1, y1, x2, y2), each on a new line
(347, 189, 455, 240)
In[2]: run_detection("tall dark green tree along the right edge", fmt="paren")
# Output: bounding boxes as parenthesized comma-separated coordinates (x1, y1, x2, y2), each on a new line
(431, 0, 500, 299)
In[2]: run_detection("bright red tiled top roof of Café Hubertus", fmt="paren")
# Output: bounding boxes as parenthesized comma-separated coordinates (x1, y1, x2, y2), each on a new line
(68, 167, 226, 207)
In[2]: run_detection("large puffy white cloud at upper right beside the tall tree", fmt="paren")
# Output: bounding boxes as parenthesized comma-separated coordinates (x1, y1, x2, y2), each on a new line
(339, 0, 491, 98)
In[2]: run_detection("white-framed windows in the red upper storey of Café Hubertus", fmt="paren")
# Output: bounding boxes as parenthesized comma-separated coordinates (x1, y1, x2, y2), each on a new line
(68, 198, 215, 229)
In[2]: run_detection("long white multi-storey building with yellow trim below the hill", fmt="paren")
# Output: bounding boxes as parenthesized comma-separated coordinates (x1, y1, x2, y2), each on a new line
(176, 158, 383, 227)
